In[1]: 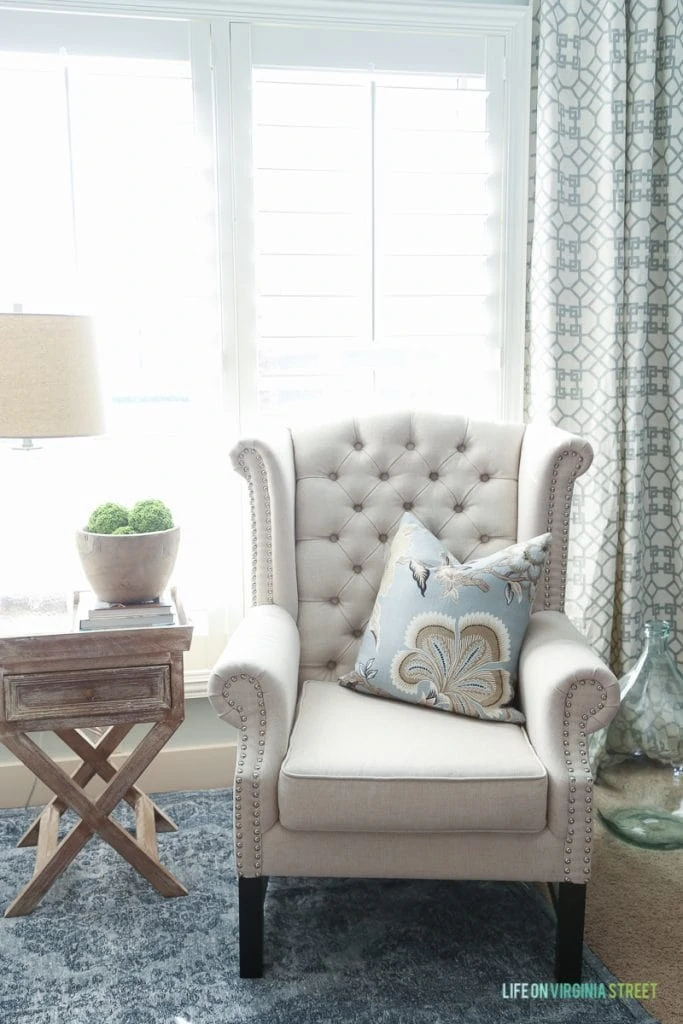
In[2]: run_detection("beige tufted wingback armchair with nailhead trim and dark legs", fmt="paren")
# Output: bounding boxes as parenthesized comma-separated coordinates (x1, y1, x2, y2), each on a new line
(209, 413, 618, 981)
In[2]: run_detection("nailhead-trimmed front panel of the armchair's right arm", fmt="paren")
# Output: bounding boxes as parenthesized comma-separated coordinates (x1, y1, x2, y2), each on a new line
(562, 679, 607, 883)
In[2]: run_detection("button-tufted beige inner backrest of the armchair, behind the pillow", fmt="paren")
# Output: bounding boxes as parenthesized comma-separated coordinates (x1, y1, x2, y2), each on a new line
(294, 414, 531, 681)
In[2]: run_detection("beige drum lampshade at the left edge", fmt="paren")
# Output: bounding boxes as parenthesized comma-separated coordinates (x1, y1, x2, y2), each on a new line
(0, 312, 104, 451)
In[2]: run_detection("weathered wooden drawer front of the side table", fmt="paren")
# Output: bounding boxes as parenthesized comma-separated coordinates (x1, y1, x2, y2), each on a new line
(3, 665, 171, 724)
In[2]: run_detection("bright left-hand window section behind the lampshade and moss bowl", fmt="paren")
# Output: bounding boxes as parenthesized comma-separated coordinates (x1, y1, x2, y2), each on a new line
(0, 18, 219, 671)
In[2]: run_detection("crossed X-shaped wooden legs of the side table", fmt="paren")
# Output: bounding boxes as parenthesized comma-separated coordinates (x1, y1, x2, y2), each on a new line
(3, 722, 187, 918)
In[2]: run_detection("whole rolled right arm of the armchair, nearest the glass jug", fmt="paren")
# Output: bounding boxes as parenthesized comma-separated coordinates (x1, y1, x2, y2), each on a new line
(519, 611, 620, 883)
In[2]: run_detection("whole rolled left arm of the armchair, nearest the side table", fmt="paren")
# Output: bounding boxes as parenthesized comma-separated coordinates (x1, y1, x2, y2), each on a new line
(209, 604, 299, 878)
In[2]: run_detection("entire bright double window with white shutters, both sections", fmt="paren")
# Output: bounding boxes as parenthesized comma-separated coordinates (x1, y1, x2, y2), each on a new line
(0, 6, 528, 679)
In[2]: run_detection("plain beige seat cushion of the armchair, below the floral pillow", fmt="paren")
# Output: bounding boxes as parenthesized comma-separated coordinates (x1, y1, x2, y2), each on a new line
(279, 681, 548, 833)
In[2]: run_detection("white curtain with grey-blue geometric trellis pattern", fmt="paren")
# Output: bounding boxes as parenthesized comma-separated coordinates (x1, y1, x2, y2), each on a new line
(526, 0, 683, 674)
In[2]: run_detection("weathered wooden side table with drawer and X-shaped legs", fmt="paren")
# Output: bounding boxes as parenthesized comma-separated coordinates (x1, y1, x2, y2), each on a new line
(0, 599, 193, 916)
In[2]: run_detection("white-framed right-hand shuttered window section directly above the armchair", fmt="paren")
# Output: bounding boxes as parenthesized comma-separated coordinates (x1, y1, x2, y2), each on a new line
(229, 18, 526, 423)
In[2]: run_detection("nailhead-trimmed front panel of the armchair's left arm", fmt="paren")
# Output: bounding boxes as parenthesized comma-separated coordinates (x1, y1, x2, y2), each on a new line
(222, 672, 267, 877)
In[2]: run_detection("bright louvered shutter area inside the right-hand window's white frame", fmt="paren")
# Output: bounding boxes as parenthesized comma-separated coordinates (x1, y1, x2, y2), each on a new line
(253, 70, 500, 420)
